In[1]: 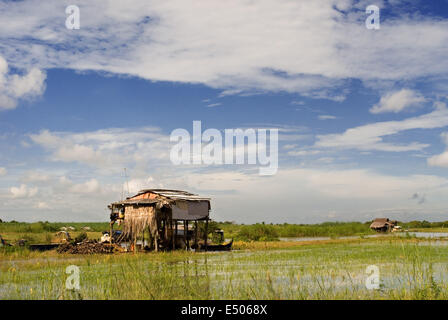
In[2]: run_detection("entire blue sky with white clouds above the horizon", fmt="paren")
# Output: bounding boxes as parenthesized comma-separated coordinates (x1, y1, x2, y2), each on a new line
(0, 0, 448, 223)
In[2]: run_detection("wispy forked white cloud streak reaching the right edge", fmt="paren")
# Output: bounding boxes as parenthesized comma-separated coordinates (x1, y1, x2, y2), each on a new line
(315, 102, 448, 152)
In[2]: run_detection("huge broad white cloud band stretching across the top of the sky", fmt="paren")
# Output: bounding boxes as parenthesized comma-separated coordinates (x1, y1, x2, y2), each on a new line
(0, 0, 448, 99)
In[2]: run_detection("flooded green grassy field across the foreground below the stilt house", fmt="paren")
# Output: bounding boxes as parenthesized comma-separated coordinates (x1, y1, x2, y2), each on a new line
(0, 237, 448, 299)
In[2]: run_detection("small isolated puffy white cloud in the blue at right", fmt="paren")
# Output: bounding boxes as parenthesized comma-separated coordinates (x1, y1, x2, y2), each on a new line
(370, 89, 426, 114)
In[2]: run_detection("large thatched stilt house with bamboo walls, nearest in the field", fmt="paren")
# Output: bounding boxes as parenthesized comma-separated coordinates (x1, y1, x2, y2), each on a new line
(108, 189, 211, 251)
